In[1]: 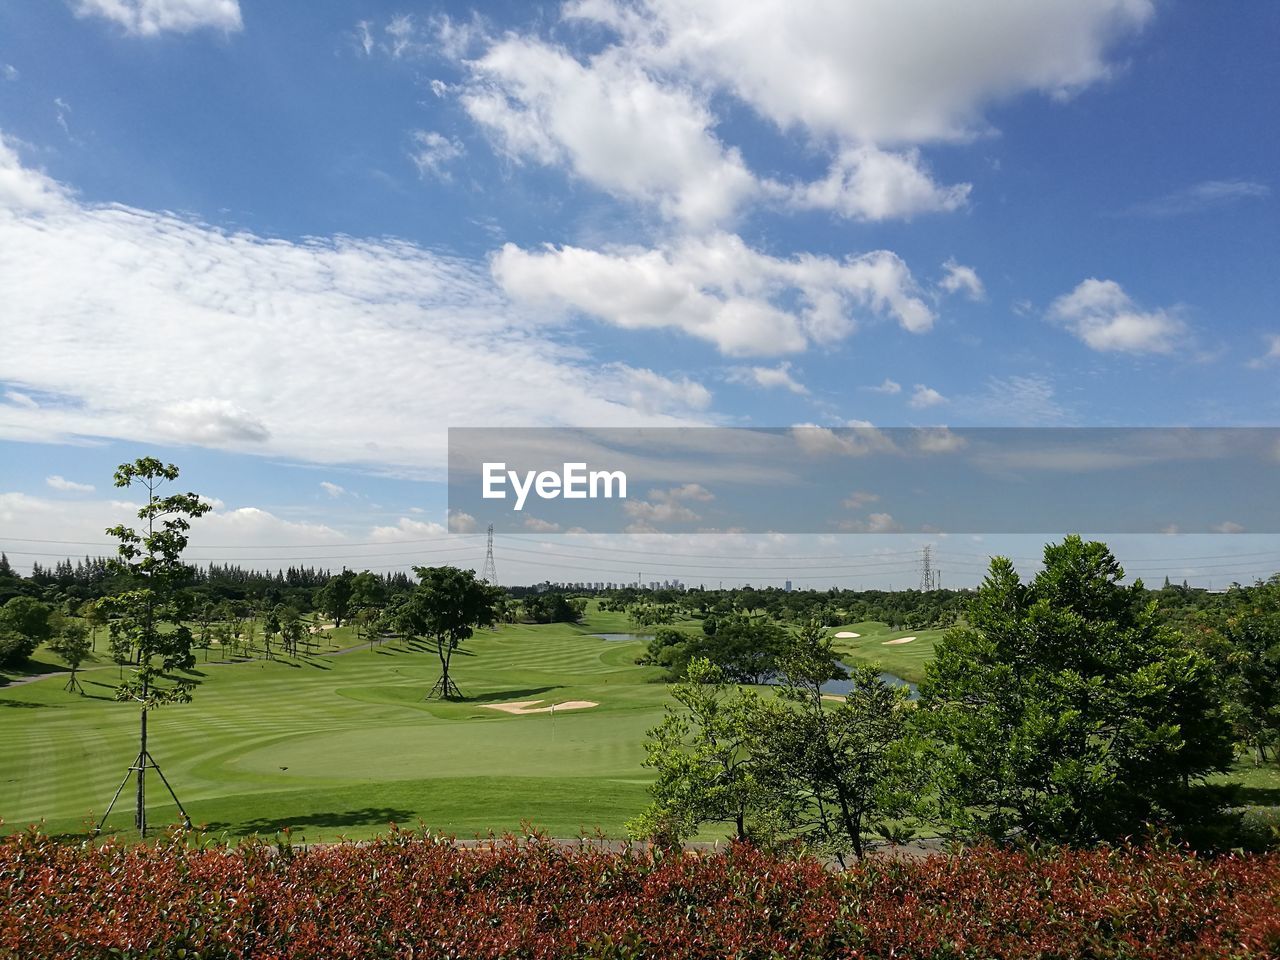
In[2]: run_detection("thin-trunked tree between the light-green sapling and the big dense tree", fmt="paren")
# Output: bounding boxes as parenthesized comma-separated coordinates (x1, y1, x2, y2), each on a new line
(756, 621, 920, 863)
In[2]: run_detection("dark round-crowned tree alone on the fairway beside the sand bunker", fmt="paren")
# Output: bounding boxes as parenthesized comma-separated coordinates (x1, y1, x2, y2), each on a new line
(394, 567, 503, 700)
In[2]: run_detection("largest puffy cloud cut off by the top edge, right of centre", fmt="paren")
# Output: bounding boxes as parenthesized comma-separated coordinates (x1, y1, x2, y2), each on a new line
(566, 0, 1155, 145)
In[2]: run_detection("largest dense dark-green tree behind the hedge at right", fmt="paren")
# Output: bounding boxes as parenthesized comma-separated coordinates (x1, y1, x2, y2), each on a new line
(920, 536, 1231, 842)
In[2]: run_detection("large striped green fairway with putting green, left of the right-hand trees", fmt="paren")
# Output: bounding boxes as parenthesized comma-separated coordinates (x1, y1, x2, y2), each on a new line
(0, 614, 667, 840)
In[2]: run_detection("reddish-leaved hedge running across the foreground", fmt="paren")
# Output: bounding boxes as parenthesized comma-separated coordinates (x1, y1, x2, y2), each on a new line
(0, 832, 1280, 959)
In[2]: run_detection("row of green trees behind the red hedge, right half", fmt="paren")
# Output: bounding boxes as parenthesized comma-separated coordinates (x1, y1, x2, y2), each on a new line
(632, 536, 1280, 855)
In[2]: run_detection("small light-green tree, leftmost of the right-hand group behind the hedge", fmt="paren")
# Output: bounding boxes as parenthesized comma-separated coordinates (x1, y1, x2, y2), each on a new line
(627, 658, 772, 844)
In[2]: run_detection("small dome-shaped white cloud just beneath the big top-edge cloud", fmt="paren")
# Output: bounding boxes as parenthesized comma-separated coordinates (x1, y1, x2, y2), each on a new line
(790, 146, 972, 220)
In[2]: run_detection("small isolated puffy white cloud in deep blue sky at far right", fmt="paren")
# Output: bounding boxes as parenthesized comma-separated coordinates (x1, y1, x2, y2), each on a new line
(1048, 278, 1187, 353)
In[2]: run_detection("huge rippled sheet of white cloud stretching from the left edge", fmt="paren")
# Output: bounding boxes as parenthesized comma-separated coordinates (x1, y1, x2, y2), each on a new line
(0, 137, 701, 475)
